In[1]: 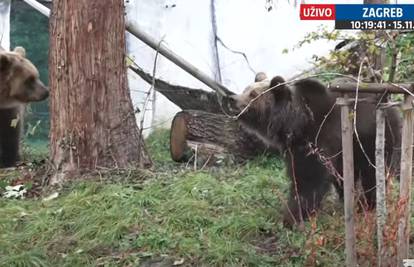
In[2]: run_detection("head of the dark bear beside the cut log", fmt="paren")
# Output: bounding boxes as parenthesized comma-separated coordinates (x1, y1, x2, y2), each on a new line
(232, 76, 312, 149)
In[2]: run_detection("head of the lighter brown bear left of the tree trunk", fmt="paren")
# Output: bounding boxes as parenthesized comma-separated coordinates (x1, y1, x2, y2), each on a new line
(0, 47, 49, 108)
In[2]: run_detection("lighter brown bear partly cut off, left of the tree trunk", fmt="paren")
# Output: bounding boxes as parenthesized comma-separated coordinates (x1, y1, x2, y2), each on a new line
(0, 47, 49, 167)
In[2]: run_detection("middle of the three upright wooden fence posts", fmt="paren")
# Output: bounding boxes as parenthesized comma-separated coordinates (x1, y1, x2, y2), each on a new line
(375, 105, 387, 267)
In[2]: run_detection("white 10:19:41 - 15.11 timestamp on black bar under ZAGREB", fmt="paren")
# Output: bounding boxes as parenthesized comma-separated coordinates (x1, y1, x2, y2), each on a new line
(335, 20, 414, 30)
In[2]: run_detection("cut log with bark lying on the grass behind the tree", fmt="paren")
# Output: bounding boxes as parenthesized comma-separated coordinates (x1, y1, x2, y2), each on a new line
(170, 110, 276, 161)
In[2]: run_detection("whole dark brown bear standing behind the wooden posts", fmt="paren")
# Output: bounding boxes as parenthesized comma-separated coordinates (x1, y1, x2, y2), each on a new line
(234, 76, 401, 226)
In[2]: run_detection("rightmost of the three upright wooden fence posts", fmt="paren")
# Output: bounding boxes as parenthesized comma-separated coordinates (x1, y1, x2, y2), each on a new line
(397, 95, 413, 266)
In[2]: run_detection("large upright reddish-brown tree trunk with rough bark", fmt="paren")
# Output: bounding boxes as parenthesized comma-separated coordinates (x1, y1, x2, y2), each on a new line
(49, 0, 151, 182)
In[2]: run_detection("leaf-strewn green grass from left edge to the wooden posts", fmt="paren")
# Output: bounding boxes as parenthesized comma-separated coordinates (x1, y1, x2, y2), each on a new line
(0, 131, 410, 266)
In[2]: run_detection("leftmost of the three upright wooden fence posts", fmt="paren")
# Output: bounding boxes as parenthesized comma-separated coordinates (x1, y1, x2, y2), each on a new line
(337, 95, 357, 267)
